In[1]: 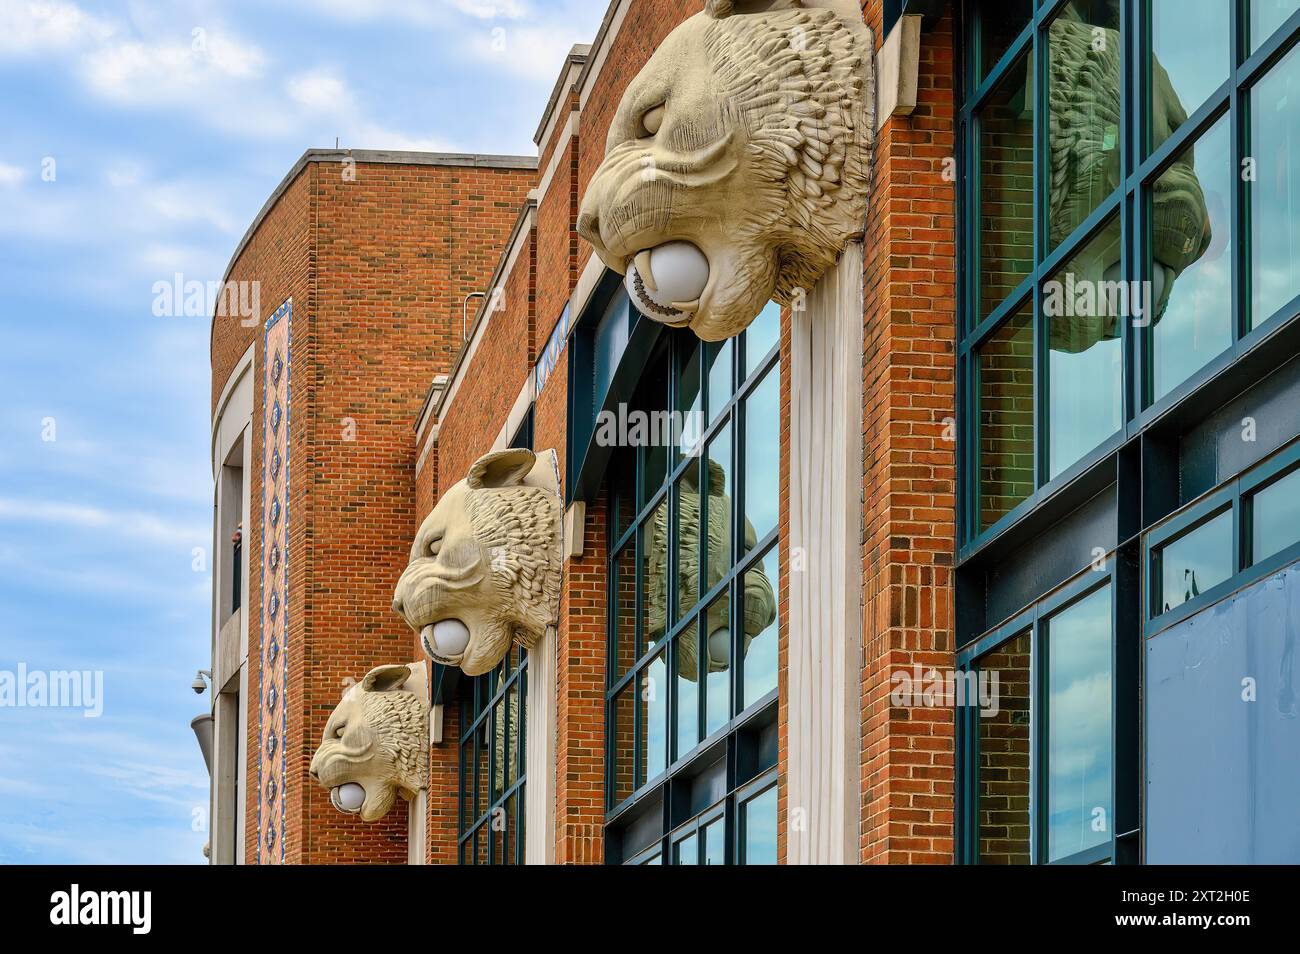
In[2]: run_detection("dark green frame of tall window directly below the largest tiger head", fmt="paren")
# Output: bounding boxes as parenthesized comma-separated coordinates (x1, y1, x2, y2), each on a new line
(605, 308, 783, 864)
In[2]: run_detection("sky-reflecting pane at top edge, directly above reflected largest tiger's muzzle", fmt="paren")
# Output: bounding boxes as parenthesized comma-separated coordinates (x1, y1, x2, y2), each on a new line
(1149, 0, 1231, 151)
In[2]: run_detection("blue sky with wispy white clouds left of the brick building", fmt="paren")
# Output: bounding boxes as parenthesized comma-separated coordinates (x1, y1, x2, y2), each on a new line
(0, 0, 606, 863)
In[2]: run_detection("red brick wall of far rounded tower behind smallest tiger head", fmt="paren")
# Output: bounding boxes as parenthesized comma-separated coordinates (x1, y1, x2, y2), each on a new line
(212, 162, 536, 863)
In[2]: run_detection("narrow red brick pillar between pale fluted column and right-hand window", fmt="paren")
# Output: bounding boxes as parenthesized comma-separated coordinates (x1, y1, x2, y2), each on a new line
(862, 0, 957, 863)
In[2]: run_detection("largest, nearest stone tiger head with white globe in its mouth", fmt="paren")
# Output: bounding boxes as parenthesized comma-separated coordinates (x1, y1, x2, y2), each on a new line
(579, 0, 875, 341)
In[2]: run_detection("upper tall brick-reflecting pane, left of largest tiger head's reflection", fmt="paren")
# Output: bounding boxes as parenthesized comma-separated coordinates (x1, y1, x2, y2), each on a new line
(979, 55, 1034, 318)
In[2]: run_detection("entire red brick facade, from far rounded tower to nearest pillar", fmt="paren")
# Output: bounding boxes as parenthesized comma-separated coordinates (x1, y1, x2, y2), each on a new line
(212, 0, 967, 863)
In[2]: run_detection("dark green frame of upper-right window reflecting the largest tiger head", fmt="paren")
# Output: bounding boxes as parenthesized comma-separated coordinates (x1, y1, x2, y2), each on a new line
(958, 0, 1300, 559)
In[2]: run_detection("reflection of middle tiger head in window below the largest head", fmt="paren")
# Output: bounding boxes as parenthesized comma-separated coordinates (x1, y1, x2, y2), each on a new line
(646, 460, 776, 680)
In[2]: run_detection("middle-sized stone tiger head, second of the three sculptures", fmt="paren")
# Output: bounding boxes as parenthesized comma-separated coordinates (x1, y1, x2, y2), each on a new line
(393, 448, 563, 676)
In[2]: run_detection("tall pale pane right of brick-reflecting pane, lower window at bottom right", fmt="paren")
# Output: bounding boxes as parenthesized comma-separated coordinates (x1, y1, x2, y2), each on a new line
(1047, 587, 1114, 862)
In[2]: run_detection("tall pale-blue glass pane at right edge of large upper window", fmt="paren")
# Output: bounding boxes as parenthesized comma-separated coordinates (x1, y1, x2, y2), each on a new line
(1249, 47, 1300, 326)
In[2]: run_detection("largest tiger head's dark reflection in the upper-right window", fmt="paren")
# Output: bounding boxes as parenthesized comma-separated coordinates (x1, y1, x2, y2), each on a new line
(1045, 5, 1210, 352)
